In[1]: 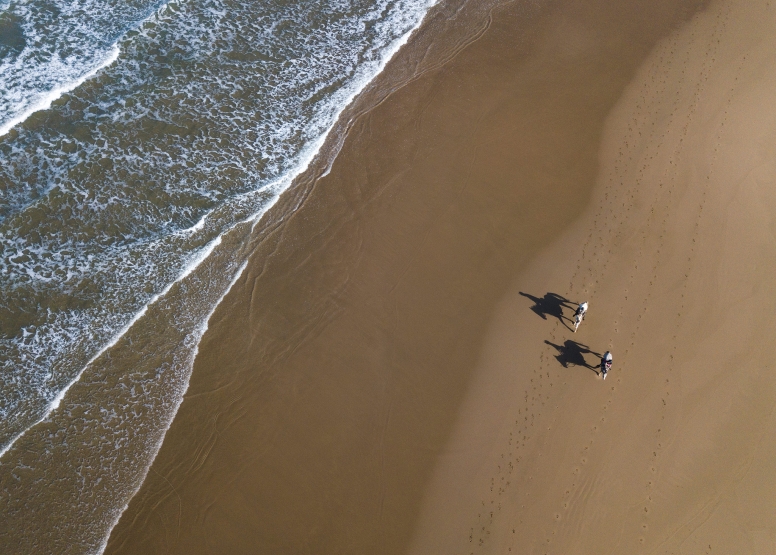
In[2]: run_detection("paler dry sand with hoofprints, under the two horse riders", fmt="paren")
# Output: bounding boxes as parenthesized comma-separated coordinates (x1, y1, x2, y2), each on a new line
(411, 1, 776, 554)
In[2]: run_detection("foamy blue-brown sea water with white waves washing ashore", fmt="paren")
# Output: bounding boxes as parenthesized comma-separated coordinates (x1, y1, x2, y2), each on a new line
(0, 0, 435, 553)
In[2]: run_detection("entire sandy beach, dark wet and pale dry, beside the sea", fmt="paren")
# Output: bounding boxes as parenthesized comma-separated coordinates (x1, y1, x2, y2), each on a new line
(106, 0, 776, 555)
